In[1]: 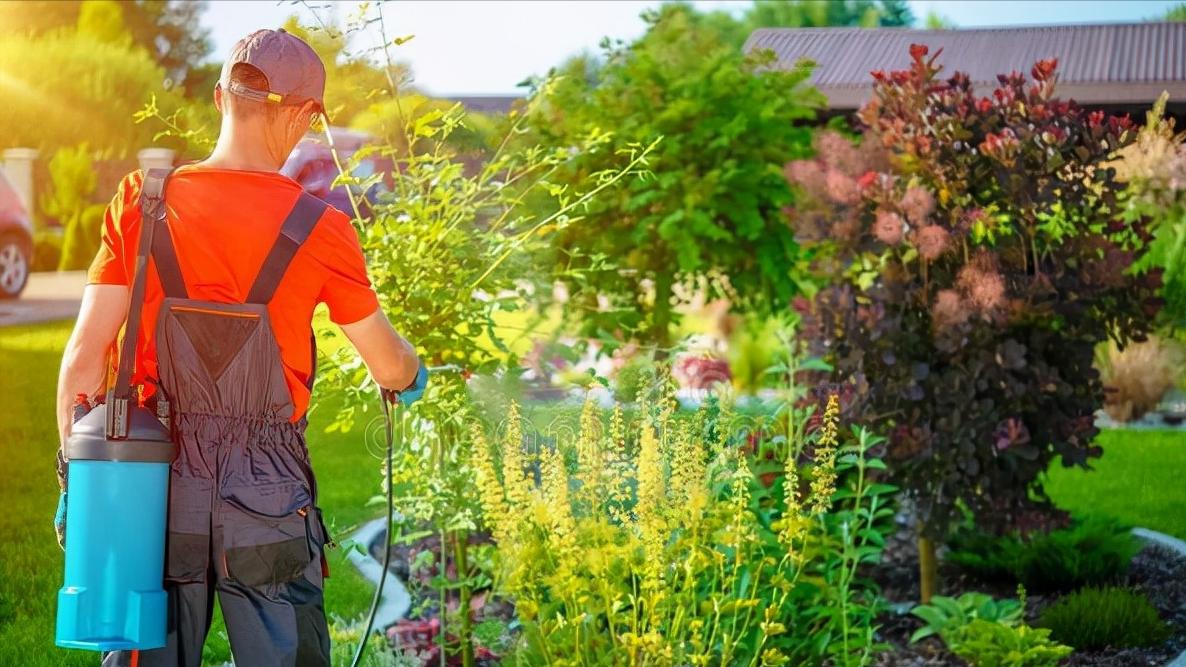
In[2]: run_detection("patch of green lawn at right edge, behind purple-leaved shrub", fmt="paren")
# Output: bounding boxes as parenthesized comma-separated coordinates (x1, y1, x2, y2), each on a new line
(1046, 431, 1186, 539)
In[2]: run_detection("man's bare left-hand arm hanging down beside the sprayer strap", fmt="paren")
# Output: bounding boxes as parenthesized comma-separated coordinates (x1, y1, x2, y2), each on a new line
(57, 285, 129, 445)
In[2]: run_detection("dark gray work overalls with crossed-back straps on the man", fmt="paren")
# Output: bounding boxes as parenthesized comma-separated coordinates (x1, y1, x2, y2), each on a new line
(103, 172, 330, 667)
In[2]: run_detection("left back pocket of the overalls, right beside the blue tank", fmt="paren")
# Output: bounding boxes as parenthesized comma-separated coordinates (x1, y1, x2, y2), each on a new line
(165, 476, 213, 584)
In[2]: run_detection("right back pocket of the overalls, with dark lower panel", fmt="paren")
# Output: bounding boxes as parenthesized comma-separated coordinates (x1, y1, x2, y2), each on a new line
(221, 482, 313, 586)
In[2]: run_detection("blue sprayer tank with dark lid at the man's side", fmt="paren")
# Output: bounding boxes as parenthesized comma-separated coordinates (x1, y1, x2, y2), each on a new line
(55, 404, 177, 650)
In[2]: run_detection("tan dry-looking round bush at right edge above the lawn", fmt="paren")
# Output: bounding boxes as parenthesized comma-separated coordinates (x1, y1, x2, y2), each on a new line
(1096, 336, 1186, 421)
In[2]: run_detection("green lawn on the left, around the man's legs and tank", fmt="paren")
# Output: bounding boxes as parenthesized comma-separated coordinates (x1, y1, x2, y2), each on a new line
(0, 322, 382, 667)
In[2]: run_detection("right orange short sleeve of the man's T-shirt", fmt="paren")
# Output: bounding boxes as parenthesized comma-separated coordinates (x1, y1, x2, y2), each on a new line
(318, 209, 378, 325)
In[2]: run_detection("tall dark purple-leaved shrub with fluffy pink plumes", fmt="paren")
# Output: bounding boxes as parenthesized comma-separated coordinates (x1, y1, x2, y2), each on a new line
(788, 45, 1158, 545)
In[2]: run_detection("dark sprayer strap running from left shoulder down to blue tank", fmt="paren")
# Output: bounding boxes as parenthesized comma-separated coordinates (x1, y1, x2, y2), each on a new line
(107, 169, 173, 438)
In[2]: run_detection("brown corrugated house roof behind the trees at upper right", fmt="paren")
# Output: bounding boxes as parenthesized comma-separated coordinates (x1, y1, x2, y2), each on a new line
(745, 22, 1186, 109)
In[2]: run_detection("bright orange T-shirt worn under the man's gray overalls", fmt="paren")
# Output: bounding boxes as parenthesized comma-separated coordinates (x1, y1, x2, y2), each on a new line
(87, 167, 378, 420)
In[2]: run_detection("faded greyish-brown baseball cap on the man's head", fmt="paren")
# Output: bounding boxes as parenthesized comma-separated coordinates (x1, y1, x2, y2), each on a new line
(218, 28, 325, 114)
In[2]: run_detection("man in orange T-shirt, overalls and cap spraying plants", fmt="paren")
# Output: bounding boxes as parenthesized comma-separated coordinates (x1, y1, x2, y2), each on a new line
(57, 30, 427, 667)
